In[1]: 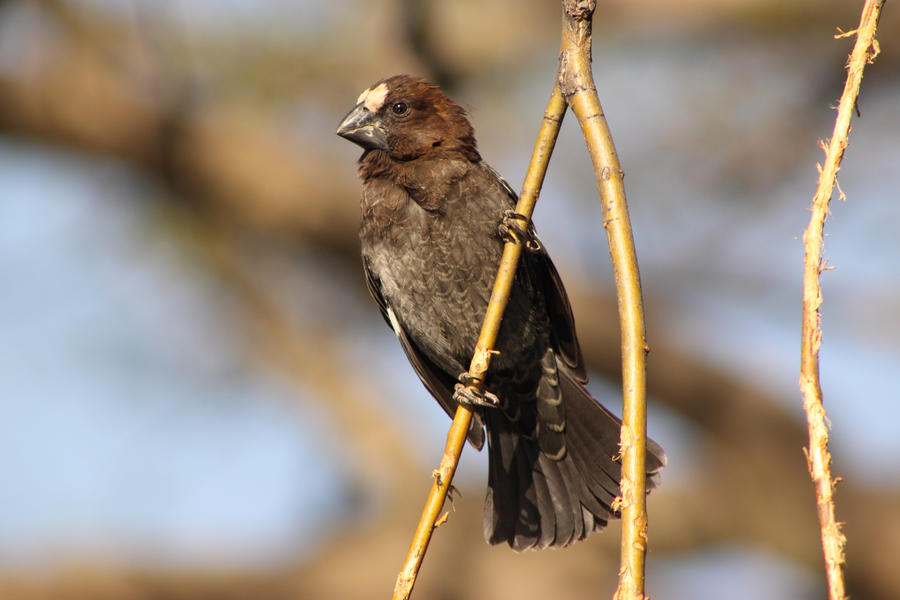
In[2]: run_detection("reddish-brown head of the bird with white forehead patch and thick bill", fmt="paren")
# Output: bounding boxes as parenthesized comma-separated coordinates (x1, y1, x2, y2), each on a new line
(337, 75, 478, 161)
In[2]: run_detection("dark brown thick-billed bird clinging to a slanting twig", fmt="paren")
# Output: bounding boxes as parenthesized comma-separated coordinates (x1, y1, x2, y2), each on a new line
(336, 75, 666, 551)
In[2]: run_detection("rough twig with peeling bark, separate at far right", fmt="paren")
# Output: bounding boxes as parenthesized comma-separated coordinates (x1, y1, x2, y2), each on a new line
(800, 0, 884, 600)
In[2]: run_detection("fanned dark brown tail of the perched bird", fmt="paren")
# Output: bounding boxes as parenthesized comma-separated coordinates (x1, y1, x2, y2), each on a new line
(484, 352, 665, 551)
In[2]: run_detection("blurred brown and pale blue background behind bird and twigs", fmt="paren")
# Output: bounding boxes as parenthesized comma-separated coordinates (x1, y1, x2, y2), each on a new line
(0, 0, 900, 600)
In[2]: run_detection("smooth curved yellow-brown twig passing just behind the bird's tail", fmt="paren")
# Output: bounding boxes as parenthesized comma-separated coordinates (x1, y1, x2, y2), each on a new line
(559, 0, 647, 600)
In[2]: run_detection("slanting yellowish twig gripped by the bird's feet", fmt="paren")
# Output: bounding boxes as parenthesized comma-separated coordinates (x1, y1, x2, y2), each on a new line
(393, 87, 566, 600)
